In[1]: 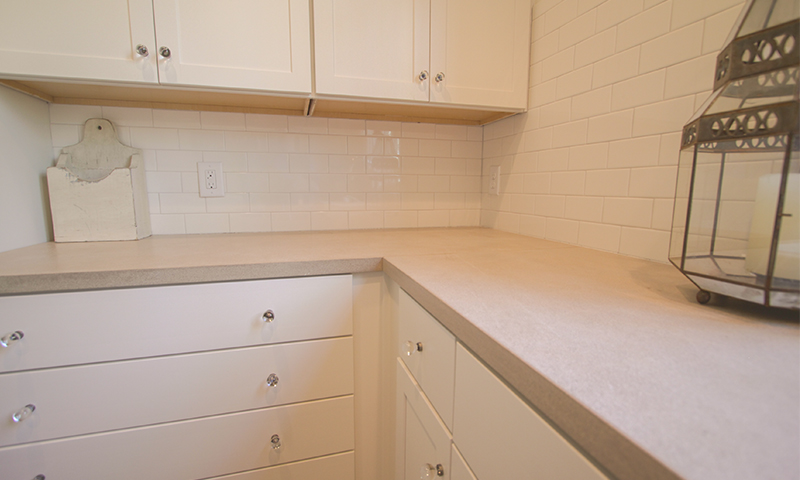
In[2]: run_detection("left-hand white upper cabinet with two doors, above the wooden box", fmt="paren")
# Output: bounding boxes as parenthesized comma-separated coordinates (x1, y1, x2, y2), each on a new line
(0, 0, 311, 93)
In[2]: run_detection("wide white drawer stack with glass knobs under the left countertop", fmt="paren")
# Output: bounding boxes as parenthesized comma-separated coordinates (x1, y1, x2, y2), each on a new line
(0, 276, 354, 480)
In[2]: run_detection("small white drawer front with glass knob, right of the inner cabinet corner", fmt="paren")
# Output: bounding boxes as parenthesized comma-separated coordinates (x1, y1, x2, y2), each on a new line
(398, 290, 456, 431)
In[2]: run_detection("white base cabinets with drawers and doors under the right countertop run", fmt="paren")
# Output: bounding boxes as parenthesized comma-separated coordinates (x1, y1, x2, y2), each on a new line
(395, 291, 606, 480)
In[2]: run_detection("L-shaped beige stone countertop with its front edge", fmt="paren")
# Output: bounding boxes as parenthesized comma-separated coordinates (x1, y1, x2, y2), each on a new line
(0, 228, 800, 480)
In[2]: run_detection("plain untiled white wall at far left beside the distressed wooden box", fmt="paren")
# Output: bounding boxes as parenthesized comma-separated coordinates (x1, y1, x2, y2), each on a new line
(0, 86, 53, 252)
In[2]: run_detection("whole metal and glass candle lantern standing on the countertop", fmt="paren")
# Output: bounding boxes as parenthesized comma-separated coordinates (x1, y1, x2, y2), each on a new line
(669, 0, 800, 309)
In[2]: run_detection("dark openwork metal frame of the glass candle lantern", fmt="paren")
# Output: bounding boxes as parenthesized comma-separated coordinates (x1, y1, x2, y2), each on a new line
(669, 0, 800, 309)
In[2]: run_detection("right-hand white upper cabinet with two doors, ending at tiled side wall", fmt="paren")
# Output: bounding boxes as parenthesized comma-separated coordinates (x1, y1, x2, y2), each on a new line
(314, 0, 531, 109)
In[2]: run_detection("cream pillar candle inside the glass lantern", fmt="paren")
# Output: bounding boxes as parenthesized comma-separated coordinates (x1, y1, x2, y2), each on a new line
(745, 173, 800, 280)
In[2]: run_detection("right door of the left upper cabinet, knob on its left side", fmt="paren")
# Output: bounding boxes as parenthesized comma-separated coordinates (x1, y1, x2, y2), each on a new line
(153, 0, 311, 93)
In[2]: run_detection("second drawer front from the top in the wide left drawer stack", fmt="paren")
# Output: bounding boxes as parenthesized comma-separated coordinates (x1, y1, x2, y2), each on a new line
(0, 337, 353, 446)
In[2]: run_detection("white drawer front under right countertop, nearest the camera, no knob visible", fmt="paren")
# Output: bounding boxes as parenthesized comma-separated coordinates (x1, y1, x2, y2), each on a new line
(453, 344, 605, 480)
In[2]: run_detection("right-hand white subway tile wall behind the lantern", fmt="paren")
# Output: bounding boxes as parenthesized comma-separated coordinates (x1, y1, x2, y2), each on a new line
(481, 0, 744, 261)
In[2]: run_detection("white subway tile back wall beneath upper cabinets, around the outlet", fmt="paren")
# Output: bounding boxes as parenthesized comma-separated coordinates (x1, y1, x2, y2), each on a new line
(50, 105, 483, 234)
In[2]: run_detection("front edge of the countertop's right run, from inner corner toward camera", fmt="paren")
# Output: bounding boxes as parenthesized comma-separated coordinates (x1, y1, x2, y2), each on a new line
(383, 259, 682, 480)
